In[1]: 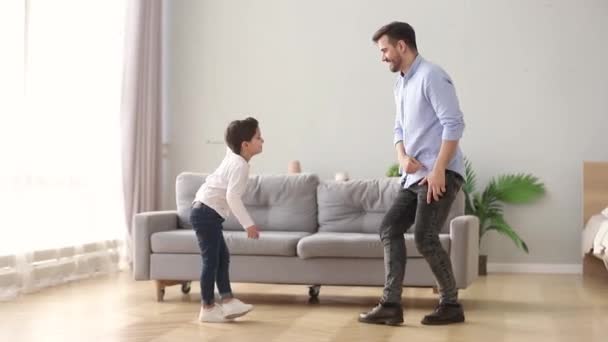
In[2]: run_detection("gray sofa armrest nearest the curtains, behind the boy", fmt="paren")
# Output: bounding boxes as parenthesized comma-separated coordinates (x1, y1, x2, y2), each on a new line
(133, 210, 177, 280)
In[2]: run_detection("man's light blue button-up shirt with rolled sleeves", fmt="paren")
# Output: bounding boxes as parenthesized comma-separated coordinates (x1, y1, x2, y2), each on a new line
(393, 55, 464, 188)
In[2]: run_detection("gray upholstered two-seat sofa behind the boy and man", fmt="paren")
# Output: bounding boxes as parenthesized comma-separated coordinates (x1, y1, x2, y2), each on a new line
(133, 173, 479, 301)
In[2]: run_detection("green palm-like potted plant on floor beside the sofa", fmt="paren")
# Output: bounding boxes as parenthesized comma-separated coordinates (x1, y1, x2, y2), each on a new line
(463, 158, 545, 275)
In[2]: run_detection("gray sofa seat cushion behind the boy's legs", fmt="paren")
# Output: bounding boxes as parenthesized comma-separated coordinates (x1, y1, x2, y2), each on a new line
(150, 229, 310, 256)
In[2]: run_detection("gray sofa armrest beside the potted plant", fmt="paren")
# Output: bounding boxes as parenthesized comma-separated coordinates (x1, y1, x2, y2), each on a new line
(450, 215, 479, 289)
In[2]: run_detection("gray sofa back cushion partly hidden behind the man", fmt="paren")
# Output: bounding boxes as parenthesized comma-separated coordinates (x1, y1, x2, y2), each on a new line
(317, 177, 464, 234)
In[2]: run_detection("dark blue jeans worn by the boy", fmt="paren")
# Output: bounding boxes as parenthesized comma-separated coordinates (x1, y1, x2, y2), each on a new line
(190, 202, 232, 305)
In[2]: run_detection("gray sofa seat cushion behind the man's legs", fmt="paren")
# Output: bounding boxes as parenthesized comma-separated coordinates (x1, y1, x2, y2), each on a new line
(298, 232, 450, 259)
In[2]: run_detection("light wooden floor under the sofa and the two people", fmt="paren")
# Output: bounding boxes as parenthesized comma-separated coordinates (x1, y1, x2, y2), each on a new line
(0, 273, 608, 342)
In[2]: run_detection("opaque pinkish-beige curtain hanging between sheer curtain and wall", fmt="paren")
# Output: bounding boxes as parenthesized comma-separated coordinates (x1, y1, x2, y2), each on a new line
(121, 0, 162, 261)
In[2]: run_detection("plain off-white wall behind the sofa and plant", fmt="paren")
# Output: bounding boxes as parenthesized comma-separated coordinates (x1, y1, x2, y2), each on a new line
(164, 0, 608, 263)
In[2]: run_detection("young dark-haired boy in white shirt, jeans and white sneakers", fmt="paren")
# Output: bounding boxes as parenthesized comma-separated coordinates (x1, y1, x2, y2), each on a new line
(190, 118, 264, 322)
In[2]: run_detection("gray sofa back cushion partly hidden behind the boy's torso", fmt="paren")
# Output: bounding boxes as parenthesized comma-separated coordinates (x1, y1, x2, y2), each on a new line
(176, 173, 319, 233)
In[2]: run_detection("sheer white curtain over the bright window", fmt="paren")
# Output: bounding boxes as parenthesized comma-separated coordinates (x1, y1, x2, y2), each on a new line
(0, 0, 126, 299)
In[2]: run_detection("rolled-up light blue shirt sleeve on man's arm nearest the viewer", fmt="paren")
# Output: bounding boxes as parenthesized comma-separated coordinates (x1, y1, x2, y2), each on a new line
(424, 68, 465, 140)
